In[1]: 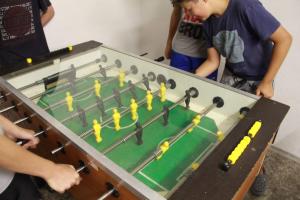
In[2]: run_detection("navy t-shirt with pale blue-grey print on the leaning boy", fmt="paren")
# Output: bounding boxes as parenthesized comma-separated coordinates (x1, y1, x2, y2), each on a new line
(204, 0, 280, 80)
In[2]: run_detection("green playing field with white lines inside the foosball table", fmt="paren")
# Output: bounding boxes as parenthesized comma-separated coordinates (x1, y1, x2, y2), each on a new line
(38, 77, 217, 195)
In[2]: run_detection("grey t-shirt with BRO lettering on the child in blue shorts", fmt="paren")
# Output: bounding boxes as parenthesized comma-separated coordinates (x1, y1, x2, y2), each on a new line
(172, 9, 207, 58)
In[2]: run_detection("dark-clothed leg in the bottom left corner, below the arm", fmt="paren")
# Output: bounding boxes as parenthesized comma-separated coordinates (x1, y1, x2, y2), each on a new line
(0, 173, 41, 200)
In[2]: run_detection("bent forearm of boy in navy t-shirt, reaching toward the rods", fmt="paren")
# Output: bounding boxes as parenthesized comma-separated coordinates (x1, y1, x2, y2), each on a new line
(196, 47, 220, 77)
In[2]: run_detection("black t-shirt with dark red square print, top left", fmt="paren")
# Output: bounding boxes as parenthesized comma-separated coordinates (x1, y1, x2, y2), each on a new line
(0, 0, 50, 73)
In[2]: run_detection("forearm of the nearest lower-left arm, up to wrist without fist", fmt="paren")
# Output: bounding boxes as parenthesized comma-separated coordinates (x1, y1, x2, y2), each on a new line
(0, 135, 54, 178)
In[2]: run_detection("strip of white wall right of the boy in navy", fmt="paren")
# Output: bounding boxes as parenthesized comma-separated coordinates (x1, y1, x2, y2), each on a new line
(262, 0, 300, 157)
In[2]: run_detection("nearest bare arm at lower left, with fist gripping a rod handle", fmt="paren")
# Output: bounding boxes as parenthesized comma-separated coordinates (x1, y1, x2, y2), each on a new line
(0, 135, 80, 193)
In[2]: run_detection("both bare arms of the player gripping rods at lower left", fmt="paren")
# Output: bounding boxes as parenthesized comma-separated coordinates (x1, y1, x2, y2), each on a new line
(0, 115, 80, 192)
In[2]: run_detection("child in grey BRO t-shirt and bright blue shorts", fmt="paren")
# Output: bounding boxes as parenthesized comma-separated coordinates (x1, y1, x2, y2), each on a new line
(165, 1, 217, 80)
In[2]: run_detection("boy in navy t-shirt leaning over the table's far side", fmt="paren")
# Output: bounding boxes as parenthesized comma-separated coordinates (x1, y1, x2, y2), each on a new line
(174, 0, 292, 98)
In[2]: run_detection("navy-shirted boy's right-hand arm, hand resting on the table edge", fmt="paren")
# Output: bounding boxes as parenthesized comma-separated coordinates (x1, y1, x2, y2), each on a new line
(256, 26, 292, 98)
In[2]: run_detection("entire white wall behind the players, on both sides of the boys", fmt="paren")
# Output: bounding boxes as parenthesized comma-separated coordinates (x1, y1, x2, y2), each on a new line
(46, 0, 300, 157)
